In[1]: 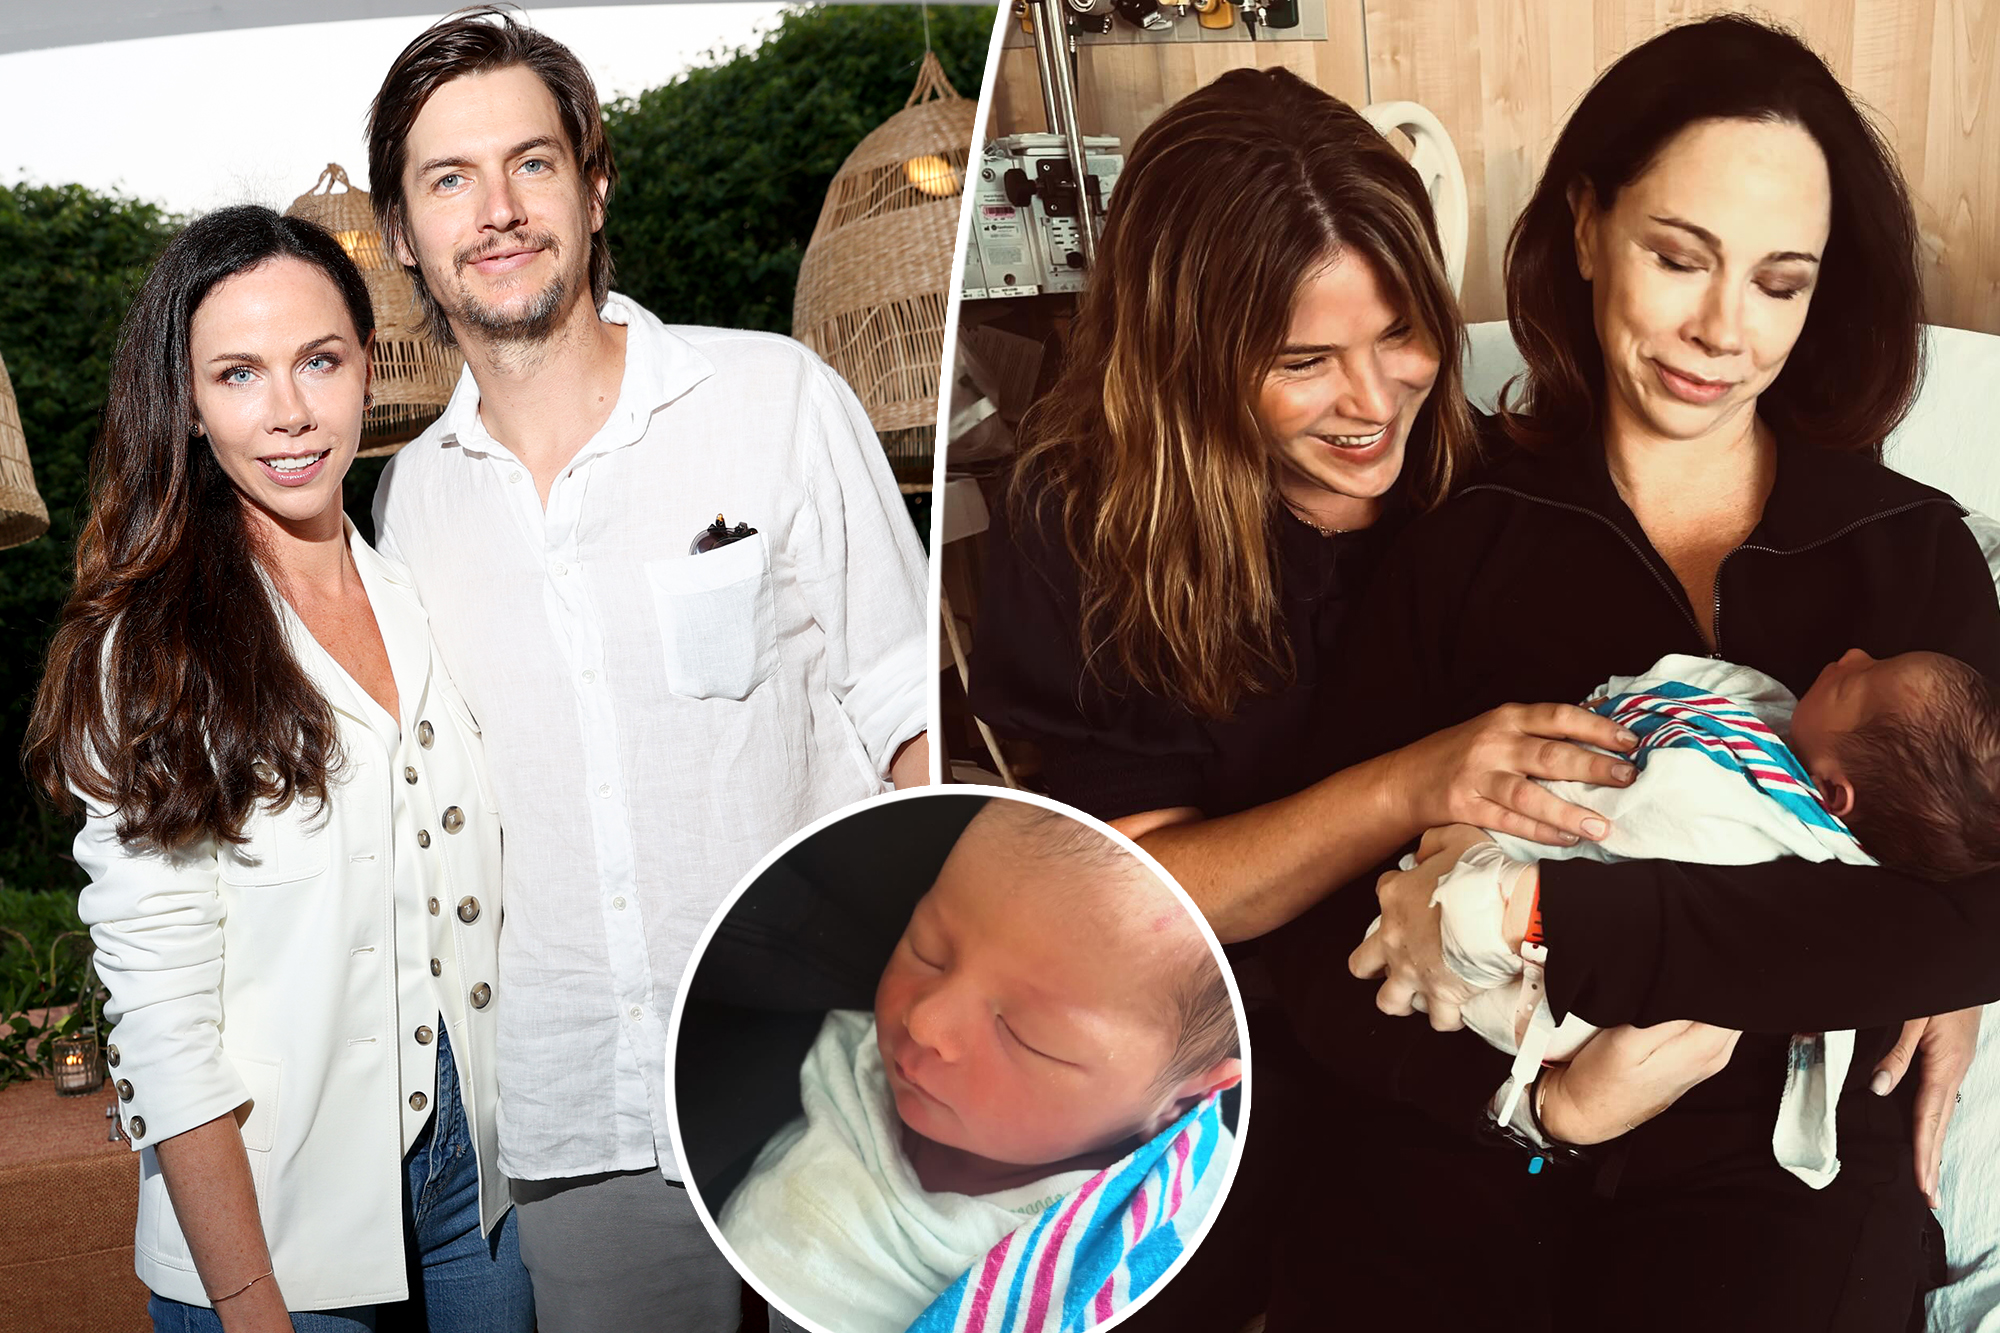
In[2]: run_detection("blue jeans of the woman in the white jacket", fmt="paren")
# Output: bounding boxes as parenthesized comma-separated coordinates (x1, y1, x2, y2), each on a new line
(146, 1023, 534, 1333)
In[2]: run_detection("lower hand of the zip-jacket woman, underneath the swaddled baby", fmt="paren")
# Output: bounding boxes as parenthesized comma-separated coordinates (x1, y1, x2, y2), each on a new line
(1538, 1021, 1742, 1145)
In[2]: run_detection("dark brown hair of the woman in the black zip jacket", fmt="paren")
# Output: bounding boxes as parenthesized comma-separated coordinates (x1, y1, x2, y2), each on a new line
(1500, 14, 1924, 458)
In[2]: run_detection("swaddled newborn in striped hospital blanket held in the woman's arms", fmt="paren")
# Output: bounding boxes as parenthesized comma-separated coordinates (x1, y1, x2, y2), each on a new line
(1436, 648, 2000, 1187)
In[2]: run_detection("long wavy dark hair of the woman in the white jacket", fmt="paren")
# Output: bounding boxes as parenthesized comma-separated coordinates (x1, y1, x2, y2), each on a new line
(24, 206, 374, 851)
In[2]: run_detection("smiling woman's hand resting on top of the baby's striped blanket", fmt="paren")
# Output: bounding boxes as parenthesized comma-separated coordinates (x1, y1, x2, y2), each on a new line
(1392, 705, 1638, 845)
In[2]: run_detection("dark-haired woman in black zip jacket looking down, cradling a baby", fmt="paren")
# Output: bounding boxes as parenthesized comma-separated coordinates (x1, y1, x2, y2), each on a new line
(1268, 18, 2000, 1331)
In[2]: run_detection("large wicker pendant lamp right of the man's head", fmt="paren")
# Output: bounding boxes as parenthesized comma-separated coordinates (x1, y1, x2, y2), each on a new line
(792, 50, 978, 482)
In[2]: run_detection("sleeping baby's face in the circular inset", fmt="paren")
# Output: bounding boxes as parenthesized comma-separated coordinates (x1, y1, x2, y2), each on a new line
(876, 823, 1192, 1165)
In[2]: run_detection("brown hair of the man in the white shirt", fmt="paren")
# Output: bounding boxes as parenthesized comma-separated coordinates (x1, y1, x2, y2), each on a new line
(368, 4, 618, 346)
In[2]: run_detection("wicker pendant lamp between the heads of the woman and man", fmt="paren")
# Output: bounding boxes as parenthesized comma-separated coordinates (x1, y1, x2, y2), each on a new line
(284, 164, 464, 458)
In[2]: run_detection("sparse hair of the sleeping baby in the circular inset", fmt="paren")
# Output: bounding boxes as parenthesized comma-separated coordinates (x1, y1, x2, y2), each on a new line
(974, 799, 1238, 1087)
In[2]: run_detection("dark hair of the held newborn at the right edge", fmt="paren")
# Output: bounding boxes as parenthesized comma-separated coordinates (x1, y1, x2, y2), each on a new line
(1838, 656, 2000, 881)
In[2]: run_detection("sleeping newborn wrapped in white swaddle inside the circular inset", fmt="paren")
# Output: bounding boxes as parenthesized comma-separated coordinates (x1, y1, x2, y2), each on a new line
(720, 799, 1240, 1333)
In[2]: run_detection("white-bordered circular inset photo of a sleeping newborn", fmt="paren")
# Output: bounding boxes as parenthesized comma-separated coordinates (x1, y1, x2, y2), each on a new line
(670, 789, 1248, 1333)
